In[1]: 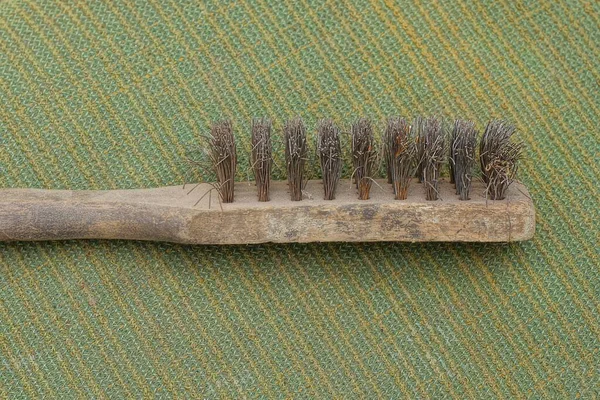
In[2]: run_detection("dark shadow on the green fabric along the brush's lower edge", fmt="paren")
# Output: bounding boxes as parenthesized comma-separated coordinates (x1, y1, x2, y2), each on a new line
(0, 240, 526, 297)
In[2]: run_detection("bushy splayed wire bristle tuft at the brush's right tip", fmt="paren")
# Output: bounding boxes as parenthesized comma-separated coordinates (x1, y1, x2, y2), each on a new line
(479, 120, 522, 200)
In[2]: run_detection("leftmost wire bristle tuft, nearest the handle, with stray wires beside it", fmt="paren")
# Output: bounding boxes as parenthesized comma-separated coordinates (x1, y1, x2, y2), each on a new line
(209, 120, 237, 203)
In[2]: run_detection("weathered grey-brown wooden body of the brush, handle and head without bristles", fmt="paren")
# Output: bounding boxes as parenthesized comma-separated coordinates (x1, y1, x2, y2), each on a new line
(0, 180, 535, 244)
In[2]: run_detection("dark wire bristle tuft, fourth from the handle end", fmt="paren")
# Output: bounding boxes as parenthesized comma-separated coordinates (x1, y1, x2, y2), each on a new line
(317, 119, 342, 200)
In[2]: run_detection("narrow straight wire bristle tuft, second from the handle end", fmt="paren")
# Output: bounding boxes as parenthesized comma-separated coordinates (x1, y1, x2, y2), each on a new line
(252, 118, 273, 201)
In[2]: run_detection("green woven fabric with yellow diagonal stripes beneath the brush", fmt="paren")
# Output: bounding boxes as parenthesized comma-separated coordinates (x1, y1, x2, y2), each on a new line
(0, 0, 600, 399)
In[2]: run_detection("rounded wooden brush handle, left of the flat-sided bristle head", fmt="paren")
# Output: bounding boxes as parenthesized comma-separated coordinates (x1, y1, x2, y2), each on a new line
(0, 186, 191, 242)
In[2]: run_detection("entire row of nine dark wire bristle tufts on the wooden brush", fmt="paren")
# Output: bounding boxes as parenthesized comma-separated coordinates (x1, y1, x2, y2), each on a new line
(199, 116, 522, 203)
